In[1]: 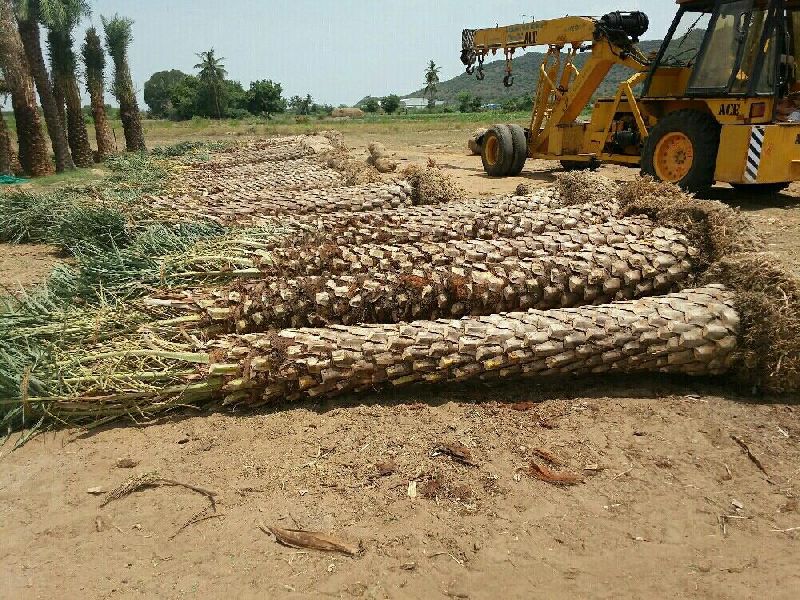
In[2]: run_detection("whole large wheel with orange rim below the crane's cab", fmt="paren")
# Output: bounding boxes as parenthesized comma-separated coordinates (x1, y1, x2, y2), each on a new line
(642, 109, 720, 192)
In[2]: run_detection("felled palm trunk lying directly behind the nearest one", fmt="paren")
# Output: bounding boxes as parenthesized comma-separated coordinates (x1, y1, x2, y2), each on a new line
(191, 230, 698, 333)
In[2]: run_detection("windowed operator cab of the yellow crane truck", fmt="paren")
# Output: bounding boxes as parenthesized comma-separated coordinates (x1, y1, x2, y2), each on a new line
(643, 0, 800, 121)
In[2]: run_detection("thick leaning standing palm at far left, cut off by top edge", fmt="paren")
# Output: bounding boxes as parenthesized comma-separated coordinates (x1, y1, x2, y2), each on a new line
(0, 0, 53, 177)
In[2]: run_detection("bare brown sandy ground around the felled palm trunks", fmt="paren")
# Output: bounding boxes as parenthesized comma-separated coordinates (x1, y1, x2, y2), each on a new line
(0, 131, 800, 599)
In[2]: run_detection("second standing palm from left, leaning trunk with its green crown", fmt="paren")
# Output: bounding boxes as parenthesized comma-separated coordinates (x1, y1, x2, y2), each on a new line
(15, 0, 75, 173)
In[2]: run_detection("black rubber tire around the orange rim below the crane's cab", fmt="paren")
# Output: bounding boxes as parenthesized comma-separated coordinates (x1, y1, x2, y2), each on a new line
(642, 109, 720, 192)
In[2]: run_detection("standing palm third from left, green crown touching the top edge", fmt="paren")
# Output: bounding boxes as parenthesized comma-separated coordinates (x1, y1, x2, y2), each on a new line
(45, 0, 94, 167)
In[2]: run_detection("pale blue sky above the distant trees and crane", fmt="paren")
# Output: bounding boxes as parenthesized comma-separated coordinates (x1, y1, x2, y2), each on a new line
(6, 0, 675, 105)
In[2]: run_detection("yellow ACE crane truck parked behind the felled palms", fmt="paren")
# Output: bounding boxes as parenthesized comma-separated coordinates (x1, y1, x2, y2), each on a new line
(461, 0, 800, 192)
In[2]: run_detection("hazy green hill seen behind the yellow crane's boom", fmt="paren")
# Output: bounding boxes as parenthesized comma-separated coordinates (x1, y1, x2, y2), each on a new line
(378, 29, 705, 106)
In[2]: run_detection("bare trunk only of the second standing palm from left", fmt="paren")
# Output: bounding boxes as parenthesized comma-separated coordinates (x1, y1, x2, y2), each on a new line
(18, 20, 75, 173)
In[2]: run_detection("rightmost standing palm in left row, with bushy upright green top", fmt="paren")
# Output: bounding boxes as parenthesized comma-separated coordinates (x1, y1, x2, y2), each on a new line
(102, 15, 147, 152)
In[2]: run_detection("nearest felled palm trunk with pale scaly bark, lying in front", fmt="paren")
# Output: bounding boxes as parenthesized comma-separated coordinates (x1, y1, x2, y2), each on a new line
(210, 286, 740, 404)
